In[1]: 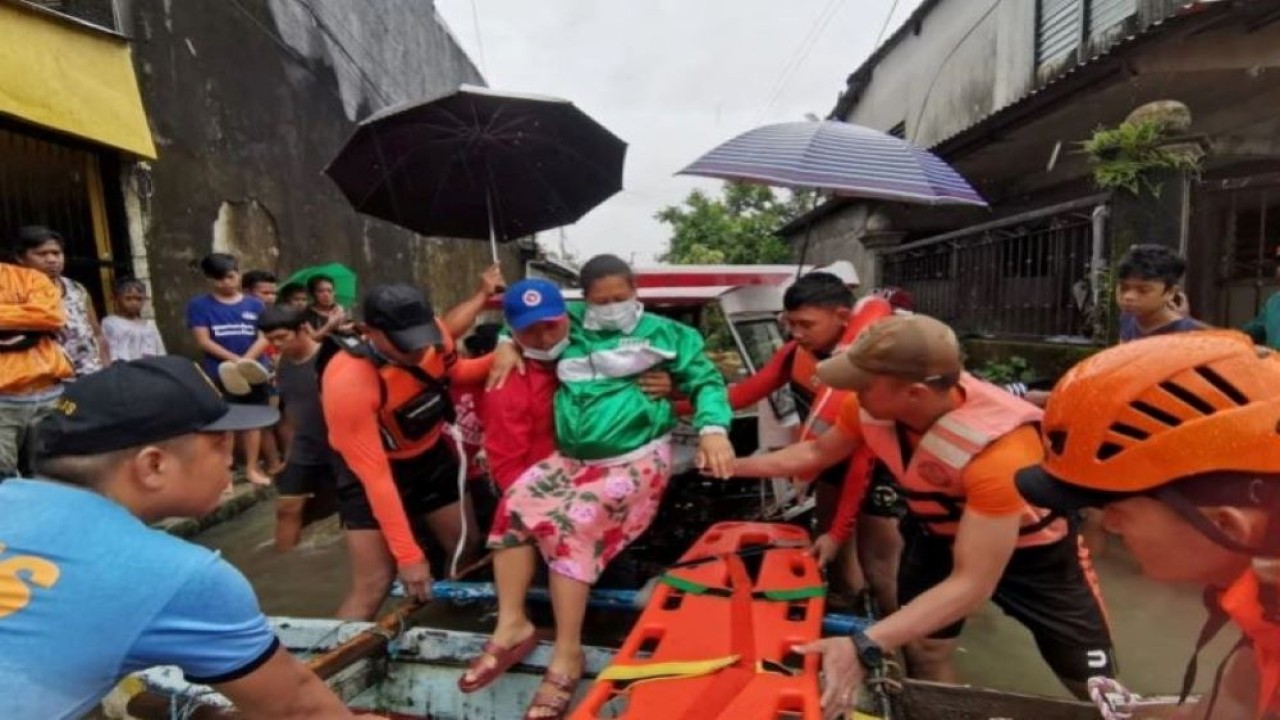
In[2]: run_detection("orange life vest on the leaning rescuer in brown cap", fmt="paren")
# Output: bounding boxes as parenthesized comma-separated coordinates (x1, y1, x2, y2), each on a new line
(859, 373, 1068, 547)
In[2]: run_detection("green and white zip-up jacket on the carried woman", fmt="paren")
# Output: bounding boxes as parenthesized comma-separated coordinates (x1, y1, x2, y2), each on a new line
(556, 302, 733, 460)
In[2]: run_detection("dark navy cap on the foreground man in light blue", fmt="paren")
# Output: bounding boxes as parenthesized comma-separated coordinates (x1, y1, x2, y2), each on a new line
(36, 355, 280, 460)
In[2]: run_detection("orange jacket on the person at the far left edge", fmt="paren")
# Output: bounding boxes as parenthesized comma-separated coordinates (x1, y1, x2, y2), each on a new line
(0, 263, 74, 395)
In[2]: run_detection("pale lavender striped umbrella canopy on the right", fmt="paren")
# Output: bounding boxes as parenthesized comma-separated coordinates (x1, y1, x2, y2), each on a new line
(680, 120, 987, 208)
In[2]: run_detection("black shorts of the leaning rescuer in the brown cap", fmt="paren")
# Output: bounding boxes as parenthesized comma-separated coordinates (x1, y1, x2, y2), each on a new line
(897, 527, 1115, 682)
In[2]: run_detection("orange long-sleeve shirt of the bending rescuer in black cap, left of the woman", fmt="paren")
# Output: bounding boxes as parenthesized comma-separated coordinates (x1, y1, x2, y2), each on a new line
(320, 351, 493, 568)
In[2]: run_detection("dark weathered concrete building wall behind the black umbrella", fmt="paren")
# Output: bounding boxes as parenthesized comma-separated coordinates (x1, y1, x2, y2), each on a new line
(112, 0, 506, 352)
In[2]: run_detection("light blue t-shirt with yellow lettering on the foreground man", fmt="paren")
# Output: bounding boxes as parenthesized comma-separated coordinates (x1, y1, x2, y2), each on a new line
(0, 479, 278, 720)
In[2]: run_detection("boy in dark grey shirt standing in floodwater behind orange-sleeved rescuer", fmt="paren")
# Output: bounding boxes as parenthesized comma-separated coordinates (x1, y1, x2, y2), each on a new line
(257, 305, 338, 552)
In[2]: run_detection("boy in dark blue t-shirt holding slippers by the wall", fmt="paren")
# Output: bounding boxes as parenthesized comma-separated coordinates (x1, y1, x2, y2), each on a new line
(187, 252, 271, 486)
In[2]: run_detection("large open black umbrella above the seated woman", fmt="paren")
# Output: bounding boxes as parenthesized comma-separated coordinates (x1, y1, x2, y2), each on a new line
(325, 86, 627, 260)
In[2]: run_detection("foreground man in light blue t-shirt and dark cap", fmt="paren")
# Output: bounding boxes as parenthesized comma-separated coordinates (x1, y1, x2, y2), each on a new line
(0, 356, 351, 720)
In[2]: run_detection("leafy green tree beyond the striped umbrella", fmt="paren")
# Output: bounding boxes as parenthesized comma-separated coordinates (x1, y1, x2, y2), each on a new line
(655, 183, 813, 265)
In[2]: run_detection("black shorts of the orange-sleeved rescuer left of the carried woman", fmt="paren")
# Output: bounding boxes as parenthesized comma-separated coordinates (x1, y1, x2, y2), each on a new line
(338, 439, 460, 530)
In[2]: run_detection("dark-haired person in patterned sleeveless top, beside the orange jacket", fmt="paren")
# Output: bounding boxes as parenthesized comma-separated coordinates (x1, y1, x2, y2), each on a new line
(18, 225, 110, 378)
